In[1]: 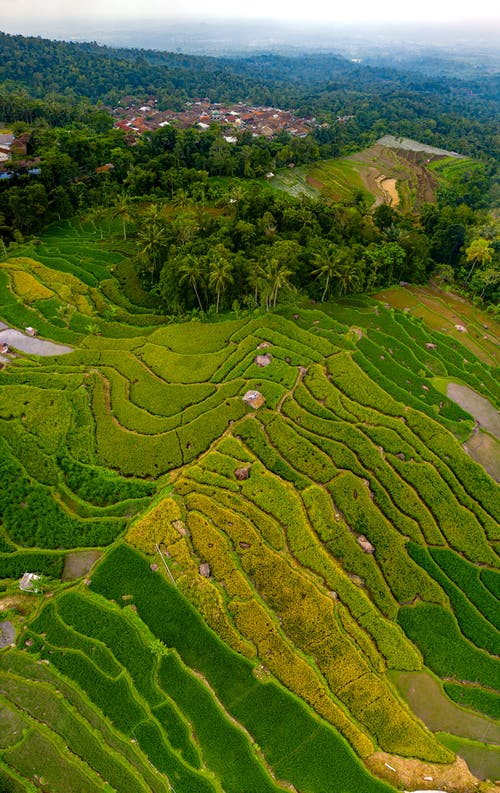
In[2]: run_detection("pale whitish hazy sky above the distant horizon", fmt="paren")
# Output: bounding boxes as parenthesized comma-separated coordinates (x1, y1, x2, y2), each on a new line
(0, 0, 500, 28)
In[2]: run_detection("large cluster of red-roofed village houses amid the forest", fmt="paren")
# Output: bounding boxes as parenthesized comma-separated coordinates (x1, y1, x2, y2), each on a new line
(111, 98, 318, 143)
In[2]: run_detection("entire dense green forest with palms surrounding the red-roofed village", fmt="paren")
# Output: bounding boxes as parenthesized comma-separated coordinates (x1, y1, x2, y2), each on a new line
(0, 34, 499, 314)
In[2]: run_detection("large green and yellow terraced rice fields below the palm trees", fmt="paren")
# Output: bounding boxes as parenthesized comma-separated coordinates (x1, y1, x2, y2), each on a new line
(0, 225, 500, 793)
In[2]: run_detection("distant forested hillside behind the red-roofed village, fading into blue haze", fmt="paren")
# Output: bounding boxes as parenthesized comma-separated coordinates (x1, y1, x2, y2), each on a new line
(0, 31, 498, 159)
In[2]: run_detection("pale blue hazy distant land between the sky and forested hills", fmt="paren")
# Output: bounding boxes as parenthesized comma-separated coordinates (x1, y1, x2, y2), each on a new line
(0, 16, 500, 53)
